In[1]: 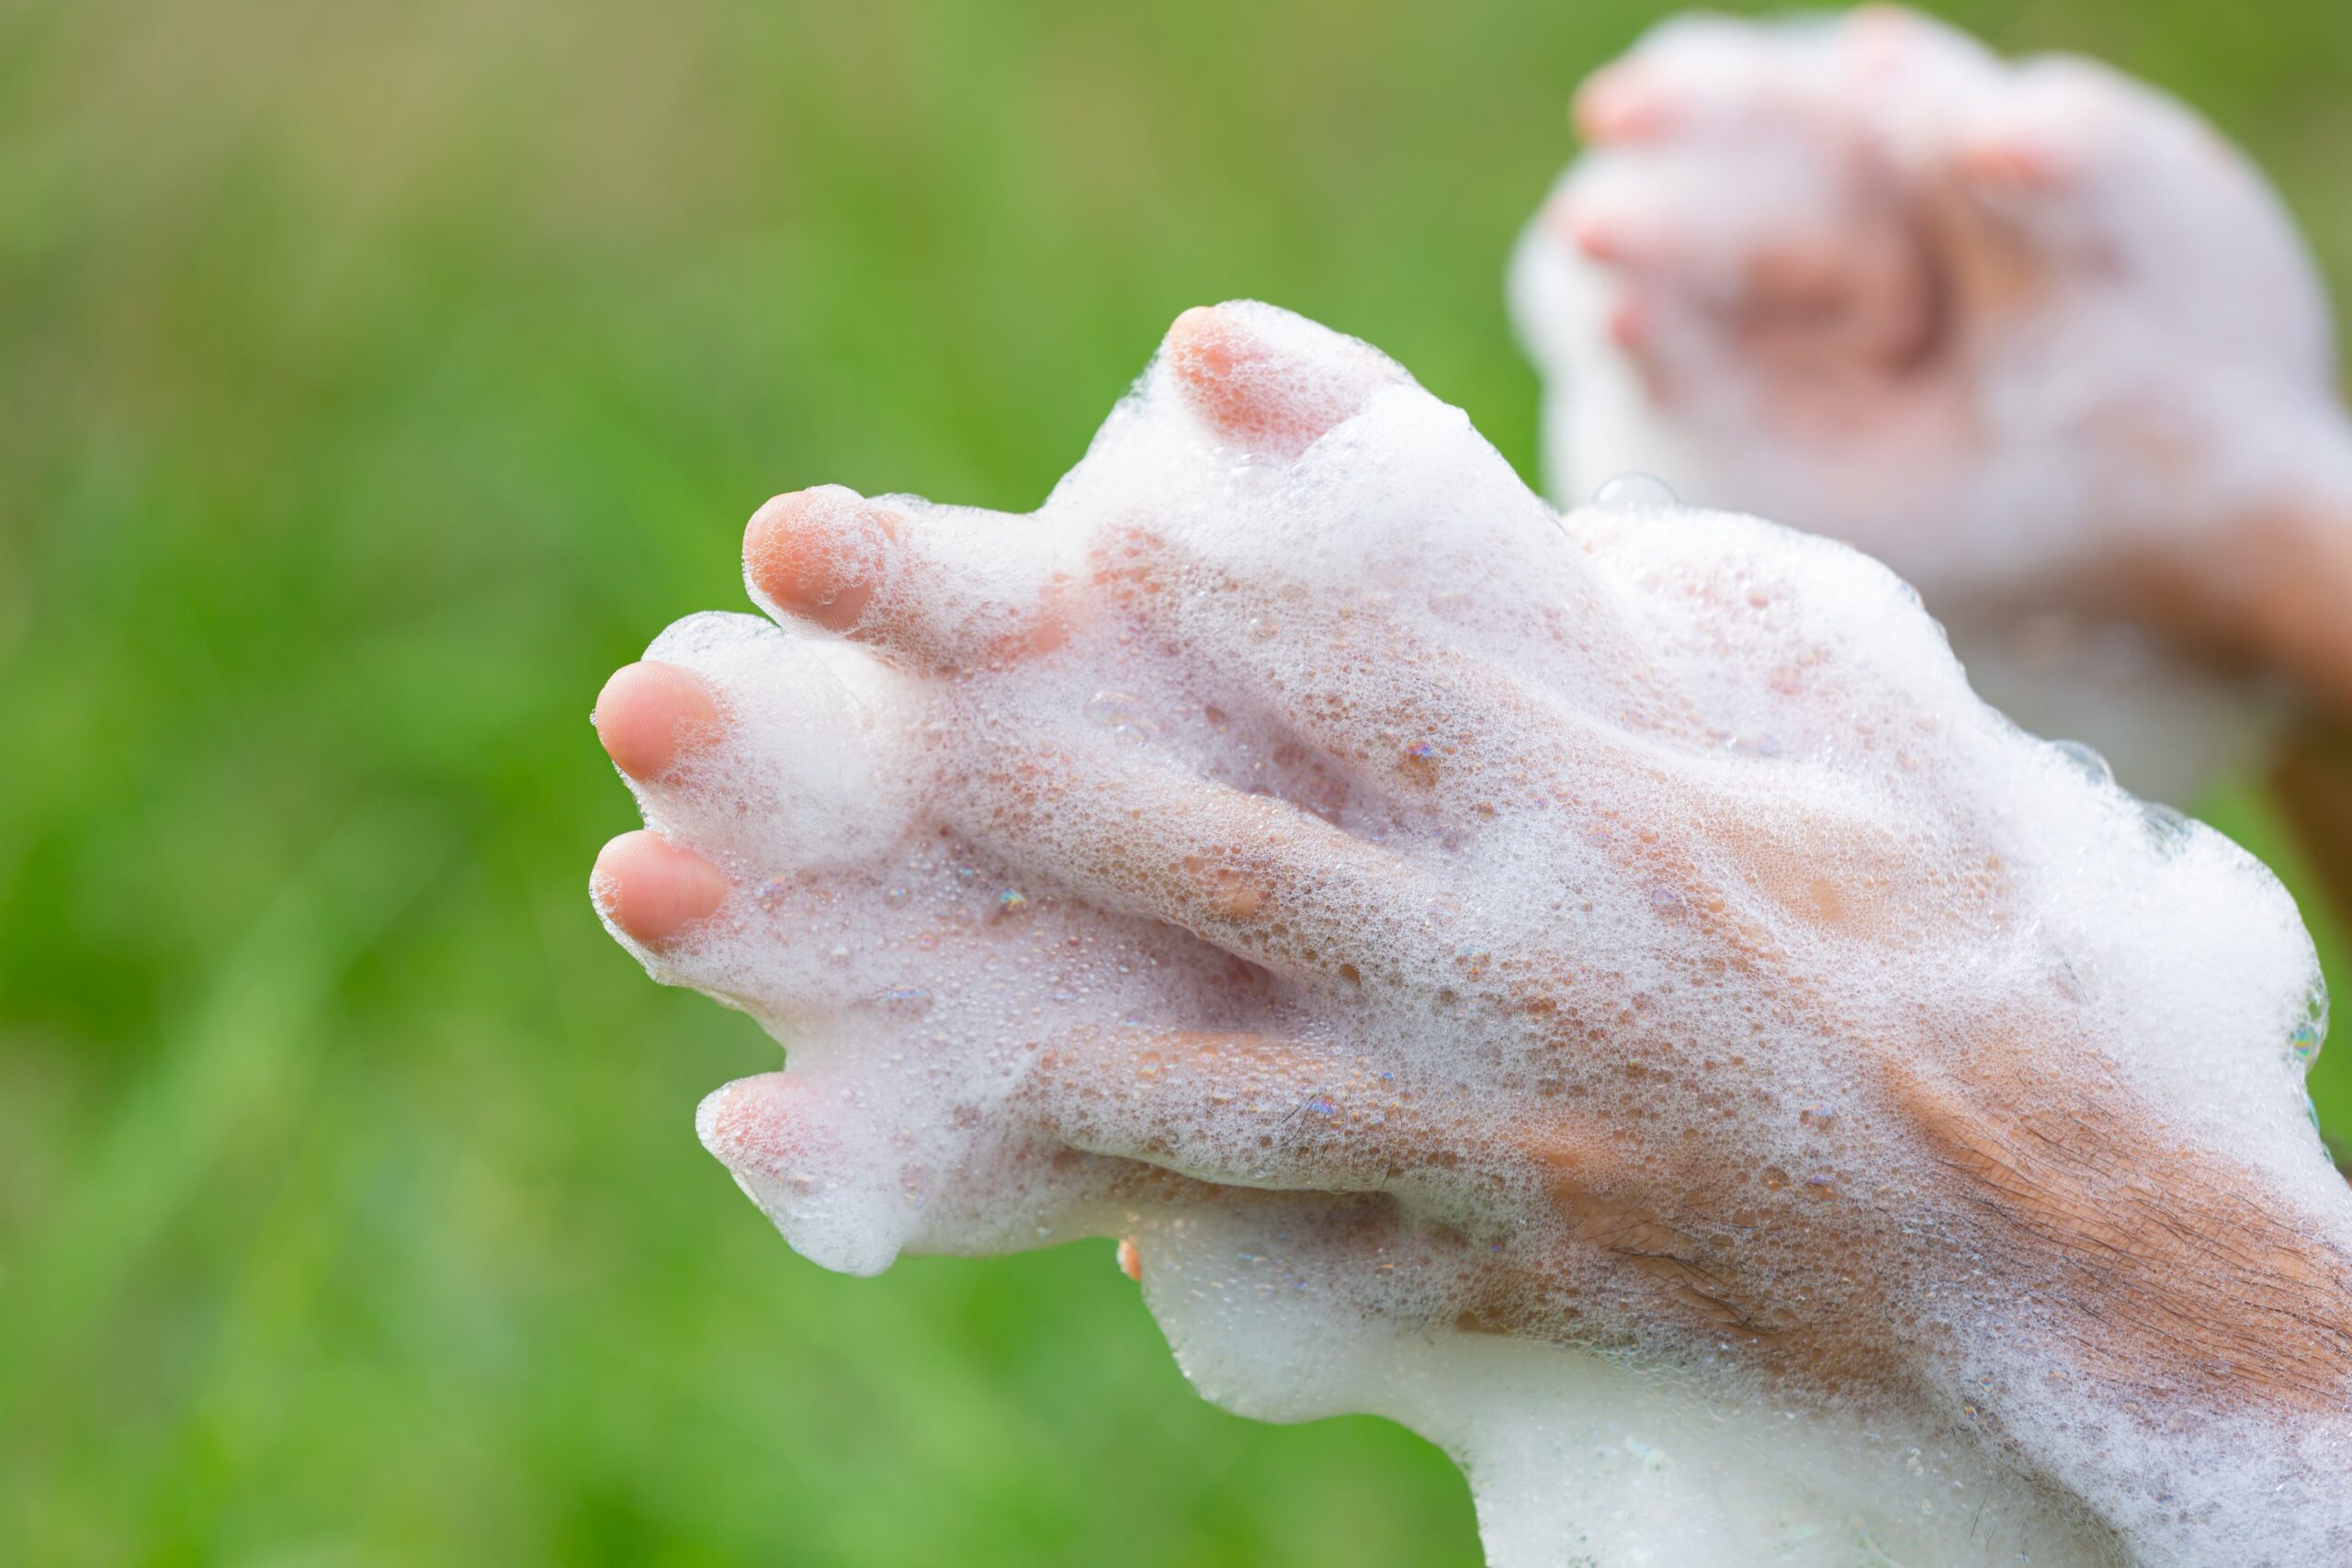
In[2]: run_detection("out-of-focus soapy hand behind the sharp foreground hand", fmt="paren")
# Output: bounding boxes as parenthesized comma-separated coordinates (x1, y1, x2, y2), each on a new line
(1512, 7, 2352, 792)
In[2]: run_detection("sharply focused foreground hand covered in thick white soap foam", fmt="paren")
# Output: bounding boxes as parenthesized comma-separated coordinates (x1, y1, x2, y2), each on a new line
(597, 306, 2352, 1563)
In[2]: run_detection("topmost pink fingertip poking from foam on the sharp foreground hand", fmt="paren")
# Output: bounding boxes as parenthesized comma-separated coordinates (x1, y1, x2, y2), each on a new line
(1159, 303, 1411, 456)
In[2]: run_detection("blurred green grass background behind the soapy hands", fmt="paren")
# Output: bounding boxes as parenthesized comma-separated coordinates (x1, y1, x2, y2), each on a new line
(0, 0, 2352, 1565)
